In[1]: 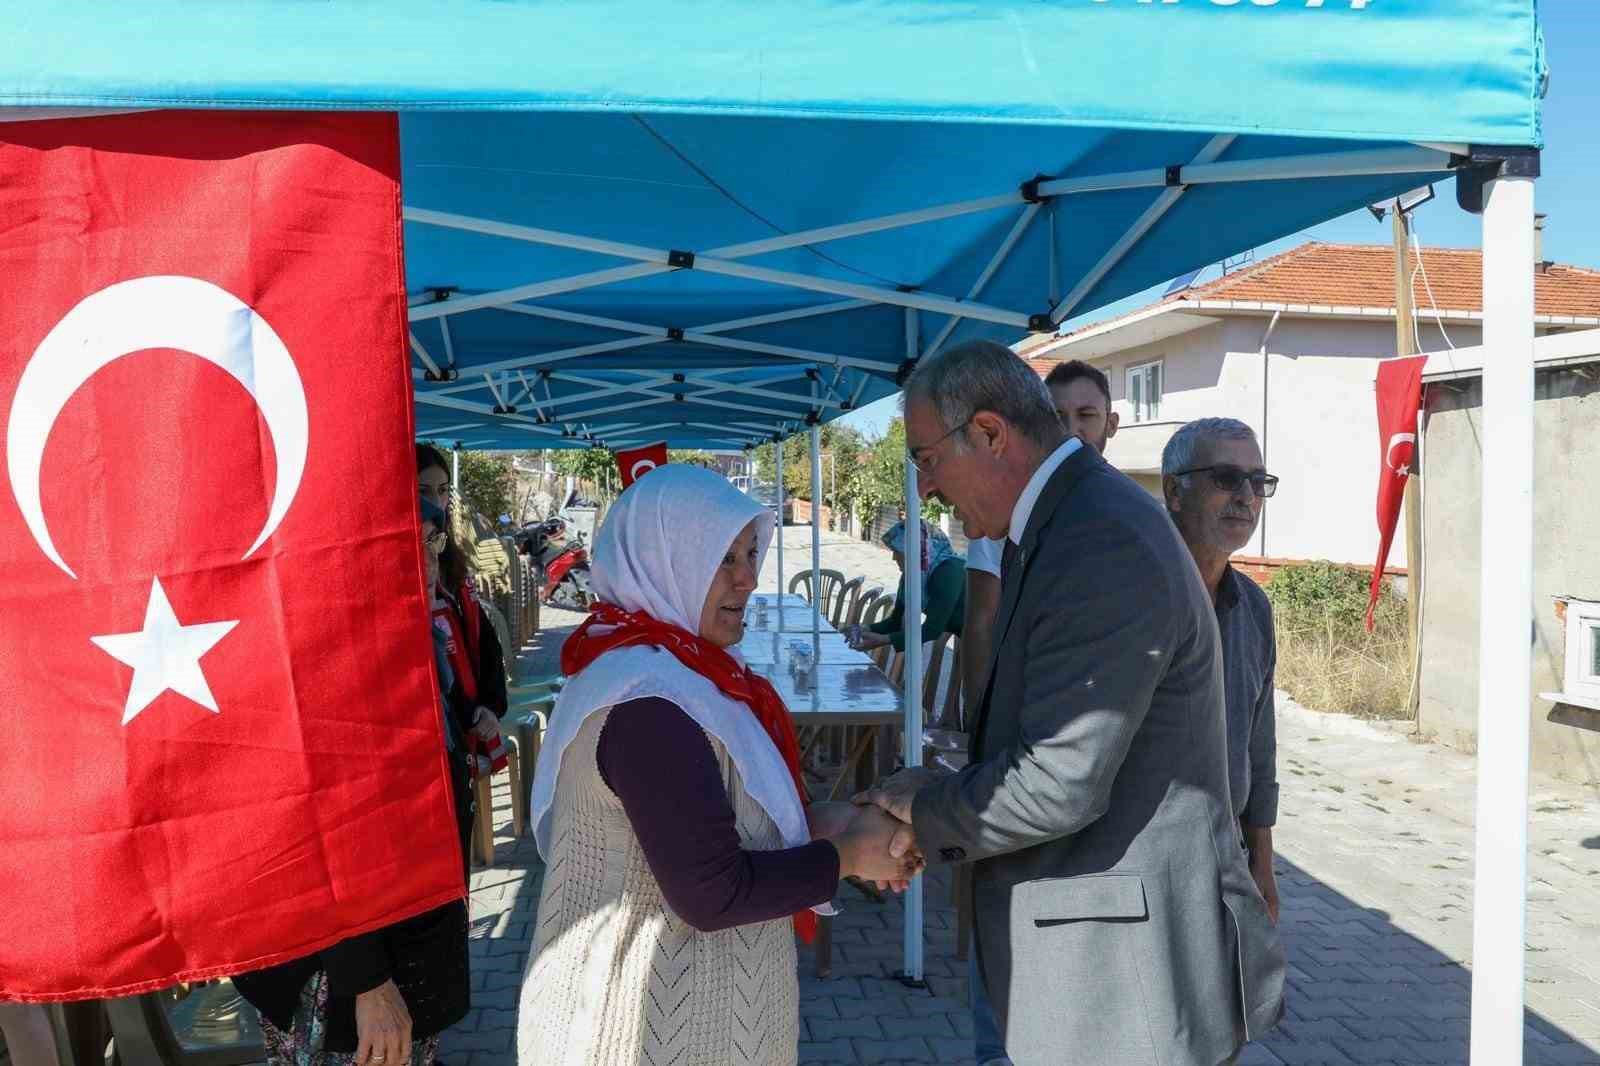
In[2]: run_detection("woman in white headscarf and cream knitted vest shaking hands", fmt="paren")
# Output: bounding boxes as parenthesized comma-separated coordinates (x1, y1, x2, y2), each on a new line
(518, 466, 917, 1066)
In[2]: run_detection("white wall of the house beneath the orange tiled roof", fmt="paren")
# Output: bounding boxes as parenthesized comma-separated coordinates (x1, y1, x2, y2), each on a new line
(1088, 315, 1480, 567)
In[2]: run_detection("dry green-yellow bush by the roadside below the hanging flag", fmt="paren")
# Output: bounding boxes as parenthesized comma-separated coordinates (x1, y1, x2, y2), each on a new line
(1266, 562, 1411, 719)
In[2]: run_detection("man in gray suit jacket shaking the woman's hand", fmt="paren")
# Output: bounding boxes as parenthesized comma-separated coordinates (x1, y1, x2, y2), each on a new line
(858, 341, 1285, 1066)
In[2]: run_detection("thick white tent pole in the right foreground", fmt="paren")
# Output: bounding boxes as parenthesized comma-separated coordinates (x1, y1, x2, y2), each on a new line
(1465, 176, 1534, 1066)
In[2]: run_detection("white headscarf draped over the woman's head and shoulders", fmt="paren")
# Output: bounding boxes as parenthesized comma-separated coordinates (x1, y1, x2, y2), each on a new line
(533, 464, 811, 860)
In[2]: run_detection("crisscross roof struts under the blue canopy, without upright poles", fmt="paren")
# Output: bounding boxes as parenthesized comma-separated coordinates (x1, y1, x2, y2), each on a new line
(403, 134, 1466, 443)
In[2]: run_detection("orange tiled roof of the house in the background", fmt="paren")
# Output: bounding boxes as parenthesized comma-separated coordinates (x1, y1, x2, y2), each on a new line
(1024, 240, 1600, 368)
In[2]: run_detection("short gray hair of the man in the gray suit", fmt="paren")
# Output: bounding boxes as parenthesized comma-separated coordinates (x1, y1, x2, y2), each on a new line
(901, 341, 1064, 450)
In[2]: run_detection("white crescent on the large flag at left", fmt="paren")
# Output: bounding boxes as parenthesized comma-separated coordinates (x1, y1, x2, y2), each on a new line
(6, 275, 310, 579)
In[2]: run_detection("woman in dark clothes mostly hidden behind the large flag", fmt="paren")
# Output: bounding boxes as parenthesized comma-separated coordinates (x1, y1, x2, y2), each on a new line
(234, 498, 470, 1066)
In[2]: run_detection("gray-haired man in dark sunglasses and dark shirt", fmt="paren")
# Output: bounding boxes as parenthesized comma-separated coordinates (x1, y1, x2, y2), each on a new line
(1162, 418, 1278, 922)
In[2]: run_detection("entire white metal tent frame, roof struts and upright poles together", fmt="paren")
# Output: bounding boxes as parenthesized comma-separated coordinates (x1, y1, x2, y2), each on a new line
(405, 136, 1533, 1066)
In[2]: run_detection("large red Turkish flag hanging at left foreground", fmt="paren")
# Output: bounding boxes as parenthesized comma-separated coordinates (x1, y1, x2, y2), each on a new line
(0, 110, 462, 1000)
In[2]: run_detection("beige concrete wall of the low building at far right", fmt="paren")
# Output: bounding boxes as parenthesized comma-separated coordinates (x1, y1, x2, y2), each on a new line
(1418, 365, 1600, 784)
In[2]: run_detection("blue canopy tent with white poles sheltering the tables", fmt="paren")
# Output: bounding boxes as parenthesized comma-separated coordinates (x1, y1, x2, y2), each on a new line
(0, 0, 1544, 1063)
